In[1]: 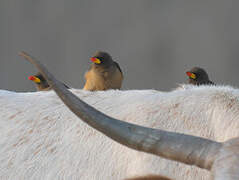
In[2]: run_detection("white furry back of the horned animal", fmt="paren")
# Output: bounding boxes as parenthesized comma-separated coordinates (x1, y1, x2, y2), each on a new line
(0, 86, 239, 180)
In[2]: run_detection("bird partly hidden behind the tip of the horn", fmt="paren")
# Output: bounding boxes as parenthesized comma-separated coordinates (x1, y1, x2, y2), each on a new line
(28, 72, 70, 91)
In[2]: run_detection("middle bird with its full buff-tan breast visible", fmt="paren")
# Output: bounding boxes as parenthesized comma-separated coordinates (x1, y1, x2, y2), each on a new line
(84, 51, 123, 91)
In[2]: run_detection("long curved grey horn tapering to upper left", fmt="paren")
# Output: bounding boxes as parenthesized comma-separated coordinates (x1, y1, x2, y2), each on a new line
(20, 52, 222, 170)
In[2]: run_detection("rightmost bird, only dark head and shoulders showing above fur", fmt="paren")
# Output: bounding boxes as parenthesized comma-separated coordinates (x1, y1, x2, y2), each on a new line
(186, 67, 215, 85)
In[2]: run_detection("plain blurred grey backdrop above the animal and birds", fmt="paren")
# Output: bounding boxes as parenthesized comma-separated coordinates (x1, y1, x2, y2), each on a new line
(0, 0, 239, 91)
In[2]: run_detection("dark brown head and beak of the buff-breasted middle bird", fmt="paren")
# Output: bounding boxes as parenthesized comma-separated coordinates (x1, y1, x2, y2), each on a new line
(90, 51, 113, 66)
